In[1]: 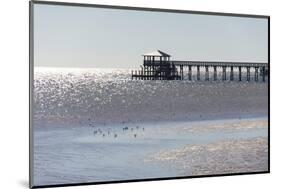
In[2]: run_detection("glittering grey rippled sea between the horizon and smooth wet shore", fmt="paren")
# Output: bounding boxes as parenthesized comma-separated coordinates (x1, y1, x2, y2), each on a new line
(33, 68, 268, 127)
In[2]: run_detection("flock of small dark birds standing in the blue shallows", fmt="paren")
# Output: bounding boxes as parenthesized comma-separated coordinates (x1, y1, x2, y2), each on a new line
(88, 118, 145, 138)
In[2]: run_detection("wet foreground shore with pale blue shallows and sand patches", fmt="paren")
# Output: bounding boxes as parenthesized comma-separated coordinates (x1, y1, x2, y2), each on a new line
(34, 118, 267, 185)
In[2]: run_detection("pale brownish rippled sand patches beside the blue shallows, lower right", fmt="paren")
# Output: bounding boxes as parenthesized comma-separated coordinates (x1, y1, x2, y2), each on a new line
(147, 120, 268, 176)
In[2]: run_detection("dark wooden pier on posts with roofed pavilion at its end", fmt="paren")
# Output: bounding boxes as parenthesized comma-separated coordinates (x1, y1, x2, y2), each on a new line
(132, 50, 268, 81)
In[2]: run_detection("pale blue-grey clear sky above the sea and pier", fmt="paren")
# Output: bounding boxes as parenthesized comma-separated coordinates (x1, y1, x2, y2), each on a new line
(34, 4, 268, 68)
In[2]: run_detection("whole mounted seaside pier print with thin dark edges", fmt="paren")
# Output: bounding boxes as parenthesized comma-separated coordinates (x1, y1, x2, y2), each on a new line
(29, 1, 270, 188)
